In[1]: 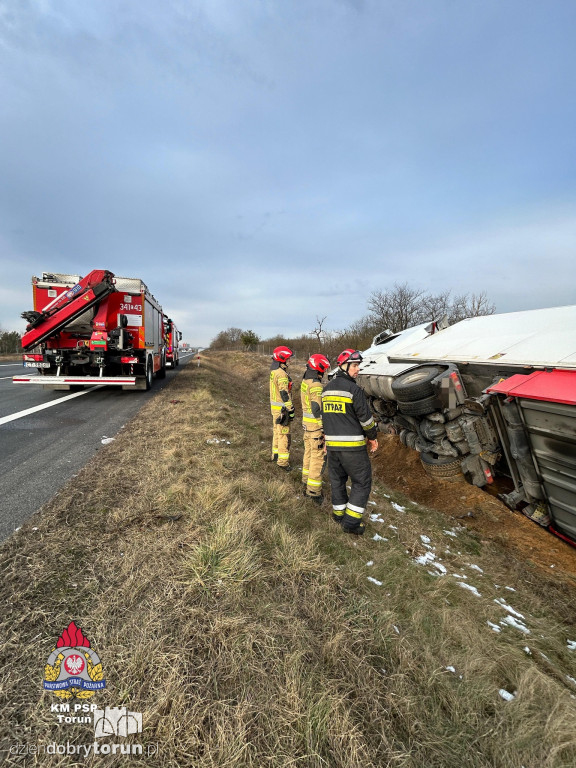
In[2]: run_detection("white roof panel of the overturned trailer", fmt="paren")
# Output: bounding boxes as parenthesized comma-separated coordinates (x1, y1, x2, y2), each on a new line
(388, 306, 576, 368)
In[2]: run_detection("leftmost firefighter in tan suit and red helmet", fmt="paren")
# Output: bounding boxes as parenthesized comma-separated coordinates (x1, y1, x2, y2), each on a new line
(270, 347, 294, 472)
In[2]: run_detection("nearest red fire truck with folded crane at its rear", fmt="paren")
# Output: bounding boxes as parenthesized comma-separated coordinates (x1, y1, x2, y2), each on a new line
(13, 269, 166, 390)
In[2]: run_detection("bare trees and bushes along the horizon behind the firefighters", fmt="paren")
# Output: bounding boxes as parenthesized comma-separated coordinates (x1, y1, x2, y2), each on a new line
(210, 283, 496, 359)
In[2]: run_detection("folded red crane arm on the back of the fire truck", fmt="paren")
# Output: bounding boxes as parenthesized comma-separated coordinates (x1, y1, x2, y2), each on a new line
(22, 269, 116, 350)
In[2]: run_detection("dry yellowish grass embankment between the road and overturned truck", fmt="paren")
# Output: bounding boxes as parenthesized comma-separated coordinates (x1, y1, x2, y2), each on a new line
(0, 353, 576, 768)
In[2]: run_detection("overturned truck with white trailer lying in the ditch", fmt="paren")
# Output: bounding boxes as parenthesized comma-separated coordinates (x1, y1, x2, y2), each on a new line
(358, 306, 576, 543)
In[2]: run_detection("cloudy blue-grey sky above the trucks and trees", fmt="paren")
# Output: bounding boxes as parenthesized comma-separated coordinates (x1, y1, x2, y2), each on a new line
(0, 0, 576, 345)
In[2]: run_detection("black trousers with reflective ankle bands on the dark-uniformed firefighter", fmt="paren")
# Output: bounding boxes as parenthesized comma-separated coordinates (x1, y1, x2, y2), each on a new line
(328, 449, 372, 530)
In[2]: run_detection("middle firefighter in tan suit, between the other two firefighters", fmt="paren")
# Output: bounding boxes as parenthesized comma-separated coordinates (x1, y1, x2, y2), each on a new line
(300, 354, 330, 505)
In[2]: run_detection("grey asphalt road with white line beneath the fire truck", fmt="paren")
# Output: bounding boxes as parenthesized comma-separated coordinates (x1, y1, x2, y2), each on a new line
(0, 354, 193, 541)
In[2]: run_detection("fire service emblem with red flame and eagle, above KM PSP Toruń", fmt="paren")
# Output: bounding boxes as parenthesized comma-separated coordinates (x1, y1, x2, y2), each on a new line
(44, 621, 106, 699)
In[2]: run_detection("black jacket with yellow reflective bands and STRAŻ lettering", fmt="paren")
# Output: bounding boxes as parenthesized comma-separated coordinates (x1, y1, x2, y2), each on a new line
(322, 368, 378, 451)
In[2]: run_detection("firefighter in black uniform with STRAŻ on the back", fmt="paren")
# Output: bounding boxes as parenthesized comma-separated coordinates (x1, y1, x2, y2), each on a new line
(322, 349, 378, 536)
